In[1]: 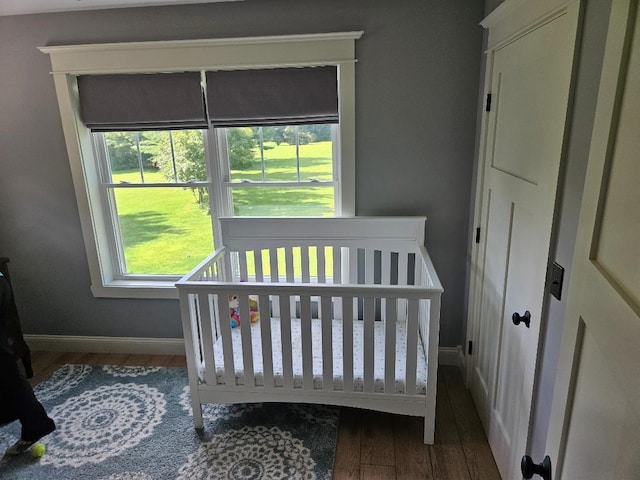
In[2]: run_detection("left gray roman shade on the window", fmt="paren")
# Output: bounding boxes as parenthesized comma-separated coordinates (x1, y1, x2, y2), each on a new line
(77, 72, 207, 131)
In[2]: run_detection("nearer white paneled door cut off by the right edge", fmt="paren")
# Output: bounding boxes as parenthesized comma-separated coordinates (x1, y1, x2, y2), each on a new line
(534, 0, 640, 480)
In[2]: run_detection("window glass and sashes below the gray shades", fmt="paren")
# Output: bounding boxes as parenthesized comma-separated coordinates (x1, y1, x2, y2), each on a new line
(93, 124, 339, 279)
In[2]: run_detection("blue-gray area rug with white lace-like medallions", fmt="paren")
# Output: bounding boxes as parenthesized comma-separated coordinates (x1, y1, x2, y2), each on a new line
(0, 365, 339, 480)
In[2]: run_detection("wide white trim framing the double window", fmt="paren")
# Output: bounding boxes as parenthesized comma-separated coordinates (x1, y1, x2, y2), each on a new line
(39, 32, 363, 298)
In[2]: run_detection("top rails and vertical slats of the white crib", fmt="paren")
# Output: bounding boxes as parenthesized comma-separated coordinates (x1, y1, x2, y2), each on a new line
(179, 247, 442, 395)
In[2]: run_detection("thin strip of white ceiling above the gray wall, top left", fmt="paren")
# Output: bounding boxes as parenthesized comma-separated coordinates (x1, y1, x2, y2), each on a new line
(0, 0, 242, 16)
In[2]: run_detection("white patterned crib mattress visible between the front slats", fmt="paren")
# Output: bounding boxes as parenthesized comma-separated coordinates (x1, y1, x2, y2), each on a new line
(200, 318, 427, 395)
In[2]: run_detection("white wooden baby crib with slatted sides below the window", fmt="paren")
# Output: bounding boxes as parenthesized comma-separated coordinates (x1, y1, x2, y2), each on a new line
(176, 217, 443, 444)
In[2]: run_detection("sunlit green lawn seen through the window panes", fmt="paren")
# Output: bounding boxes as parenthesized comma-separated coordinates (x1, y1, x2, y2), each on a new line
(113, 142, 334, 274)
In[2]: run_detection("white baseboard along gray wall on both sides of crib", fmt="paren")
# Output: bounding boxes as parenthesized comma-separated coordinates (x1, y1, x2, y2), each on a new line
(24, 335, 464, 368)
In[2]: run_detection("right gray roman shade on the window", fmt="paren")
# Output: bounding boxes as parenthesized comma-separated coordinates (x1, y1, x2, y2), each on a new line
(206, 66, 338, 127)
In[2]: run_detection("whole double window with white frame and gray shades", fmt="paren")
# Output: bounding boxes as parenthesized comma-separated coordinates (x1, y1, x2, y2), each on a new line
(41, 32, 361, 298)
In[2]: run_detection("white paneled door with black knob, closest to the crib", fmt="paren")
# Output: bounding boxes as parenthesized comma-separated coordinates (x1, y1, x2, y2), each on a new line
(470, 3, 578, 479)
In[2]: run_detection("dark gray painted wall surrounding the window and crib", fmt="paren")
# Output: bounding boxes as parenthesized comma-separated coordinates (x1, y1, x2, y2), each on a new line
(0, 0, 483, 346)
